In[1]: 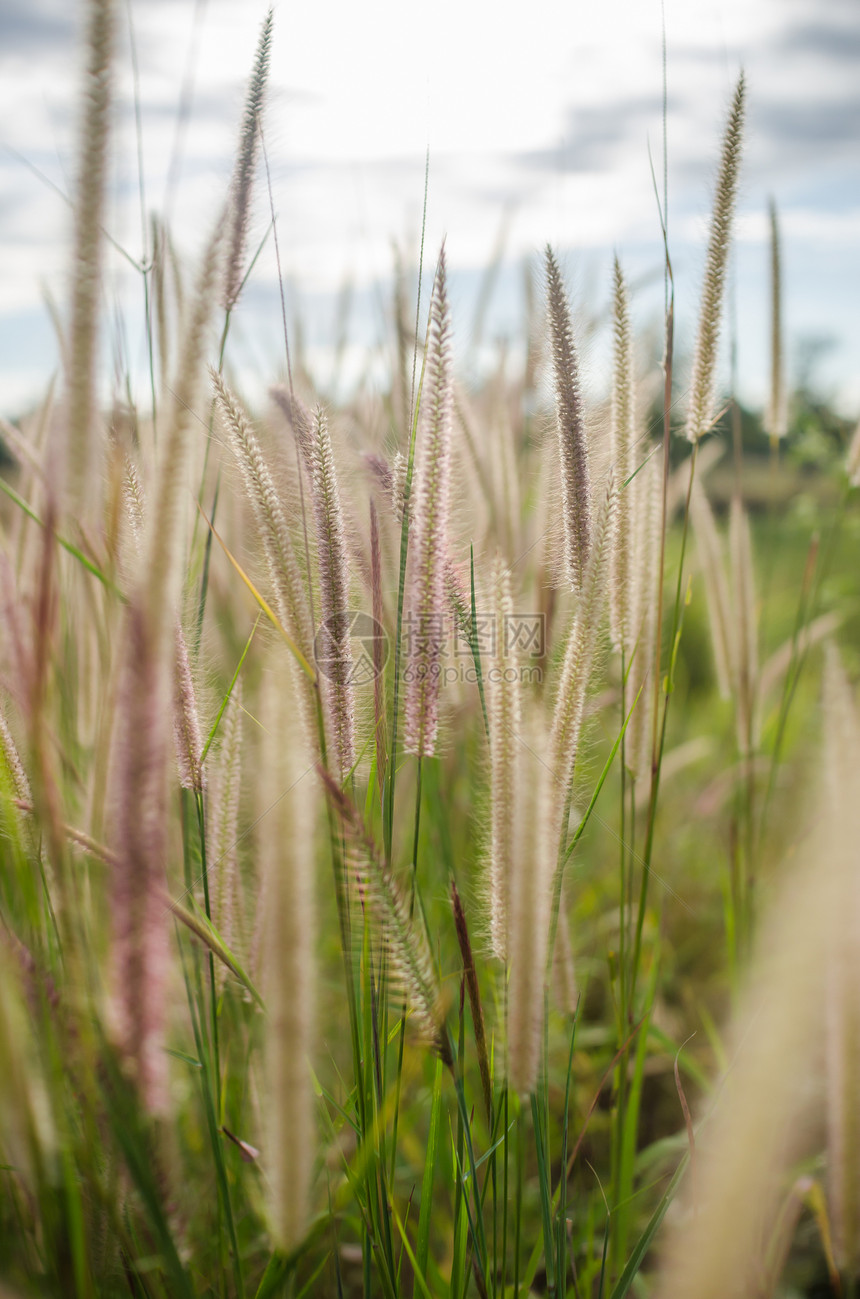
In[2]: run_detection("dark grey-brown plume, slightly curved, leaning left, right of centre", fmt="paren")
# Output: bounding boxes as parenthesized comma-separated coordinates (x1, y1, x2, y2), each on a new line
(546, 247, 591, 591)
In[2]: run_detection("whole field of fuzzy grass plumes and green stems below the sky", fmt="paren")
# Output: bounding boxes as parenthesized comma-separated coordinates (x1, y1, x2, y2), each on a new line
(0, 0, 860, 1299)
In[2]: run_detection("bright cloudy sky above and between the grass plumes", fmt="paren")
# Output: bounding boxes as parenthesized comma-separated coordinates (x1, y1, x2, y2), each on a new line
(0, 0, 860, 417)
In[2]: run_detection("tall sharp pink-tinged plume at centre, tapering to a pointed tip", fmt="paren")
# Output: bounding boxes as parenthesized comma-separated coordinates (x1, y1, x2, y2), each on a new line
(404, 244, 453, 757)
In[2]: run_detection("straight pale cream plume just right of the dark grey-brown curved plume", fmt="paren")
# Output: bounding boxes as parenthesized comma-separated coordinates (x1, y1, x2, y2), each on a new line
(609, 257, 635, 656)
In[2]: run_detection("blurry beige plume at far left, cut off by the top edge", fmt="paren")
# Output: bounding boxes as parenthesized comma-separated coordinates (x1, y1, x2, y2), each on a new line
(66, 0, 114, 512)
